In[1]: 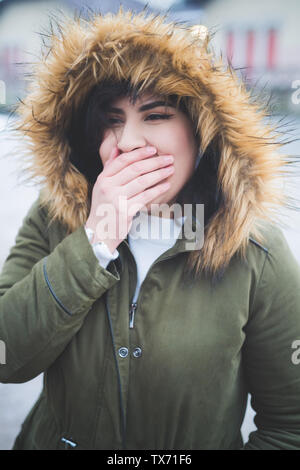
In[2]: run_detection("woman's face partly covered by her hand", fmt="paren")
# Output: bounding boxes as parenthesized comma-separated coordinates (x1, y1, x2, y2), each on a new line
(99, 93, 198, 217)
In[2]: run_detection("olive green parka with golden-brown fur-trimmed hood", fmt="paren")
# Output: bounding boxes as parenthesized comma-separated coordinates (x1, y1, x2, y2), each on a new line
(0, 6, 300, 450)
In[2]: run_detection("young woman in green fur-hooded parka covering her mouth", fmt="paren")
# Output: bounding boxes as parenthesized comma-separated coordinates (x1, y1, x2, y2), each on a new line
(0, 9, 300, 449)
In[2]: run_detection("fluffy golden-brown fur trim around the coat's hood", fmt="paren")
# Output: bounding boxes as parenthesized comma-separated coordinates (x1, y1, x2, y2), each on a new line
(7, 7, 298, 272)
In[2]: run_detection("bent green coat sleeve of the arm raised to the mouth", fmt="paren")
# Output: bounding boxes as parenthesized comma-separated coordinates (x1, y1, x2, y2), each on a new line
(0, 193, 120, 383)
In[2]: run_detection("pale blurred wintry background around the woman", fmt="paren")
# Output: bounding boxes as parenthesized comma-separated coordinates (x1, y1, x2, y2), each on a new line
(0, 0, 300, 450)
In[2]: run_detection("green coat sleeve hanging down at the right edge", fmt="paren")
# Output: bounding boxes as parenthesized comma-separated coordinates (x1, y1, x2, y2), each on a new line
(243, 227, 300, 450)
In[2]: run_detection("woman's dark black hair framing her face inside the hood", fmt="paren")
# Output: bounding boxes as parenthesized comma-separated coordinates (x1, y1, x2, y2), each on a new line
(67, 80, 220, 225)
